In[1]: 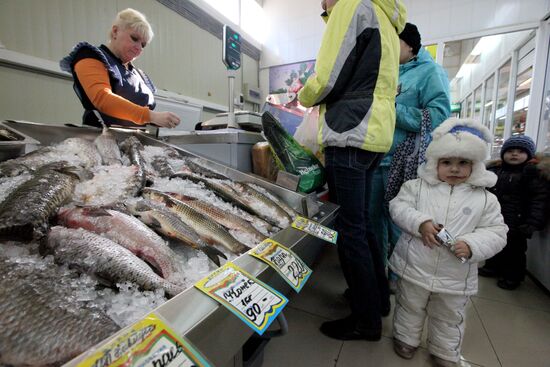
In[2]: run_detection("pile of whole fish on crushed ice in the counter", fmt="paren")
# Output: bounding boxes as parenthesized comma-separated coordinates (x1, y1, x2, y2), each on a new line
(0, 129, 297, 366)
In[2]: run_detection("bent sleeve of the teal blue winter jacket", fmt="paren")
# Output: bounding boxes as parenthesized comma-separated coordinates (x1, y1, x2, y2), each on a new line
(395, 68, 451, 133)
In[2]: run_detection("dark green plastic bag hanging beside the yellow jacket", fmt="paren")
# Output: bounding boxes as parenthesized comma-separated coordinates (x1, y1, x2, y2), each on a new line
(262, 112, 325, 193)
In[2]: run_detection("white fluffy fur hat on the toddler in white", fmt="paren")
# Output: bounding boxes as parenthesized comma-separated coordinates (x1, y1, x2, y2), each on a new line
(418, 117, 496, 187)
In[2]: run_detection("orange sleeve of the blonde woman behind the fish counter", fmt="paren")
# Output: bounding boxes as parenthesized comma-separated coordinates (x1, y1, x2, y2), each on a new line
(74, 58, 151, 125)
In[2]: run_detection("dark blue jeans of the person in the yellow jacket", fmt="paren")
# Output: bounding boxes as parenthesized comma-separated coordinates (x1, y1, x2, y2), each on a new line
(325, 147, 389, 331)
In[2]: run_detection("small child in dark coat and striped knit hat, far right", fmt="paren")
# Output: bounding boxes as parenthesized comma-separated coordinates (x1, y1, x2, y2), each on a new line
(479, 135, 549, 290)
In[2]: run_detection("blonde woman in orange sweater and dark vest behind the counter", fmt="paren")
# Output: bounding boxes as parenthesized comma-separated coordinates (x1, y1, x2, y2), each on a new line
(60, 8, 180, 128)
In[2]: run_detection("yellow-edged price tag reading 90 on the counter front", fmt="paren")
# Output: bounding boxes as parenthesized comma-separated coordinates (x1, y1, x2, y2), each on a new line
(195, 262, 288, 335)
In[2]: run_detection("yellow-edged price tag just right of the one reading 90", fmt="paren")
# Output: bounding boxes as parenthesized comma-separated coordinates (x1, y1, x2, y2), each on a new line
(248, 238, 311, 292)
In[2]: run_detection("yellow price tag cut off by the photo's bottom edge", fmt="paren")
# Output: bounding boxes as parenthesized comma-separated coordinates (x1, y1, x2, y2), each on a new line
(78, 313, 212, 367)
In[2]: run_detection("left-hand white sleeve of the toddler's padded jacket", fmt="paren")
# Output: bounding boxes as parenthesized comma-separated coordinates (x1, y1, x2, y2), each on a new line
(390, 179, 433, 237)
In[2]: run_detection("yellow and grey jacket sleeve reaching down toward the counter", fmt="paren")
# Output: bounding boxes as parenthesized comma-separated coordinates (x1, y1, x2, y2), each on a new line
(298, 1, 375, 107)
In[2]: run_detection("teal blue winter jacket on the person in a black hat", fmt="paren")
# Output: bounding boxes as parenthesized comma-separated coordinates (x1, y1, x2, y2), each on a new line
(381, 47, 451, 166)
